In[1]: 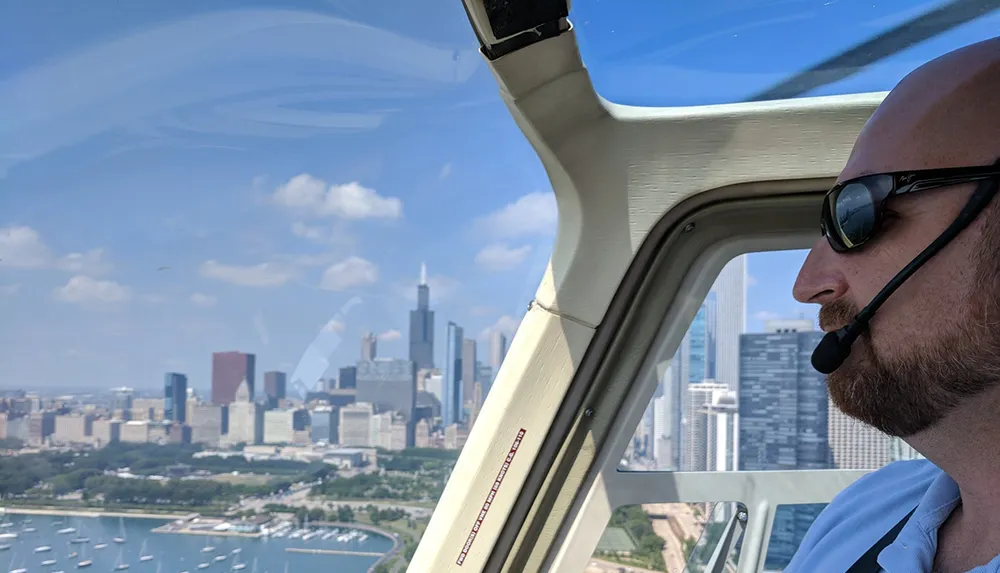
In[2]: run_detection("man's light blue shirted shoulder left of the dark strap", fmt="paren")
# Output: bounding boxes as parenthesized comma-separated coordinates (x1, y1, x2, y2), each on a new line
(786, 460, 941, 573)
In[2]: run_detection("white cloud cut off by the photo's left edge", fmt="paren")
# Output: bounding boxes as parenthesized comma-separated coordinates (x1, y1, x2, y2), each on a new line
(0, 225, 111, 275)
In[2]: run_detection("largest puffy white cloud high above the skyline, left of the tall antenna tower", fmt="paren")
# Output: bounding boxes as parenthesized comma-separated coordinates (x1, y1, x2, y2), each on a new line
(272, 173, 403, 219)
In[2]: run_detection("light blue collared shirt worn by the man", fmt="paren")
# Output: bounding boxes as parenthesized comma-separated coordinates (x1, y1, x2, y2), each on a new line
(784, 460, 1000, 573)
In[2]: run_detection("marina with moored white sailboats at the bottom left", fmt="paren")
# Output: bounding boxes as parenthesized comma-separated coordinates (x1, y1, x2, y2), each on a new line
(0, 511, 396, 573)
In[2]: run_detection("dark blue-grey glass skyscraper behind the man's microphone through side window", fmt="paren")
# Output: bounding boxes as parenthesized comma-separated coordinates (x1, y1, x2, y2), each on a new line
(738, 324, 832, 570)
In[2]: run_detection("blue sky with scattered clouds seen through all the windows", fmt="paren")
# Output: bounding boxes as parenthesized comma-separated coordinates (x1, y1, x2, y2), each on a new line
(0, 0, 997, 388)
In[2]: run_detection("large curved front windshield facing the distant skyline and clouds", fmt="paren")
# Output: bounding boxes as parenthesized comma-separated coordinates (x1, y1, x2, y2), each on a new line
(0, 0, 556, 572)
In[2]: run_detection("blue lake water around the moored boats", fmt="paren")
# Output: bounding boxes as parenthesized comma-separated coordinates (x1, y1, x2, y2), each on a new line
(0, 514, 392, 573)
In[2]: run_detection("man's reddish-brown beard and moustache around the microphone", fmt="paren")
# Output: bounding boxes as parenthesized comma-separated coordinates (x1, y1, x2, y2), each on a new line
(819, 290, 1000, 438)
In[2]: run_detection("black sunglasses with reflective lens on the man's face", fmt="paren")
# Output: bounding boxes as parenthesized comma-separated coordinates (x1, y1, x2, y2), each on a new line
(820, 164, 1000, 253)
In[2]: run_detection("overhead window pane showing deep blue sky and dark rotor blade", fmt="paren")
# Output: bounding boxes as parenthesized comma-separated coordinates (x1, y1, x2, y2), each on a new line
(570, 0, 1000, 106)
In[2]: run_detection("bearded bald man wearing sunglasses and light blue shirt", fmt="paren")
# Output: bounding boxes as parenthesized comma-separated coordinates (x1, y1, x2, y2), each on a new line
(785, 39, 1000, 573)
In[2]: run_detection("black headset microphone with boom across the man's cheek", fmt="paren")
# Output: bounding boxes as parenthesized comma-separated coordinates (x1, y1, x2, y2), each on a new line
(812, 171, 1000, 374)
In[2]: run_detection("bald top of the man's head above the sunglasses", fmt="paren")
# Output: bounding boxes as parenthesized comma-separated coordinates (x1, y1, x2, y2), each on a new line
(841, 38, 1000, 180)
